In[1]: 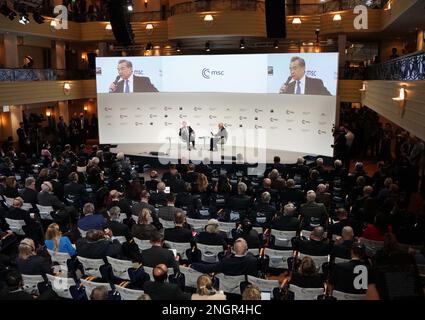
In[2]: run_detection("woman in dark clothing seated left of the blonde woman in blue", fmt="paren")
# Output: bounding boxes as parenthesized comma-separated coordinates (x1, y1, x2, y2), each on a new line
(16, 238, 52, 275)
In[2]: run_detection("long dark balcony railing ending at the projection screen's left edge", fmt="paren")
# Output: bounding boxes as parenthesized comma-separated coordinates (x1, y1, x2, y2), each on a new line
(0, 69, 96, 82)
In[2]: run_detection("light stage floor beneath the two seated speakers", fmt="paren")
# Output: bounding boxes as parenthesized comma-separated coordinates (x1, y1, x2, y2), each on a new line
(111, 144, 314, 165)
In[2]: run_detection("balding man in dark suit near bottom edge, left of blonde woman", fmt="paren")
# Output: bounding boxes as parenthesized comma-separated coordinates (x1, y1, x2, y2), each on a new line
(143, 264, 191, 300)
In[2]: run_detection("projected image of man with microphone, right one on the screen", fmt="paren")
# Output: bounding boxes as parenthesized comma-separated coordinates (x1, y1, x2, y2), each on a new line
(279, 57, 331, 96)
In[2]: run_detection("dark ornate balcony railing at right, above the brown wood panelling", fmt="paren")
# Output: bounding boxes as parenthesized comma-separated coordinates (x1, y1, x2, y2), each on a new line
(367, 51, 425, 81)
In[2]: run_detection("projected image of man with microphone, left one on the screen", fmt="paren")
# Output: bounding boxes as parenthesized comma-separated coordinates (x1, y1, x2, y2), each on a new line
(109, 60, 158, 93)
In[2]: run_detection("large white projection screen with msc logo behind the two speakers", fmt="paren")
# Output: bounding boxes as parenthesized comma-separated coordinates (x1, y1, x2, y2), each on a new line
(96, 53, 338, 156)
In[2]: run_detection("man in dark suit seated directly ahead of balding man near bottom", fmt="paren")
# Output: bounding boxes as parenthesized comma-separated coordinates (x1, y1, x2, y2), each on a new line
(142, 231, 179, 273)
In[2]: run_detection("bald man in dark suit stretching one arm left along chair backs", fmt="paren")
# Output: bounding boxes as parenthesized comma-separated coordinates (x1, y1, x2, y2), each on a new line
(191, 238, 258, 277)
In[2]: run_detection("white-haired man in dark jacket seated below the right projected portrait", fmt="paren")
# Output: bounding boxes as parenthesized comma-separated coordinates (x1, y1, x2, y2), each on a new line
(300, 190, 328, 231)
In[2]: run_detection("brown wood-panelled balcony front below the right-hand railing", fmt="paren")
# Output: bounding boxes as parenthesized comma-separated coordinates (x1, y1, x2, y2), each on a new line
(362, 81, 425, 140)
